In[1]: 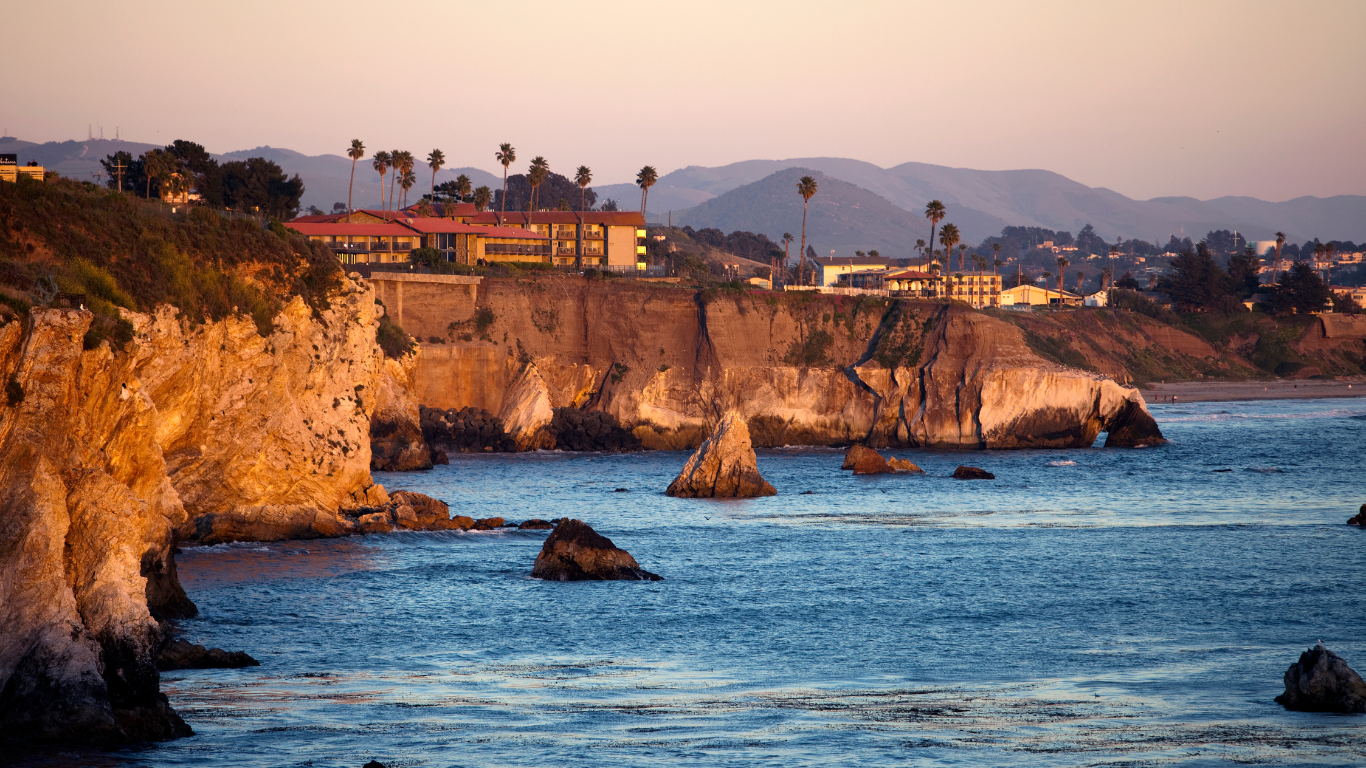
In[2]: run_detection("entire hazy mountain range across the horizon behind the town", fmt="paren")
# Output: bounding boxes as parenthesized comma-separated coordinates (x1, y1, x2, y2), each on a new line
(0, 137, 1366, 245)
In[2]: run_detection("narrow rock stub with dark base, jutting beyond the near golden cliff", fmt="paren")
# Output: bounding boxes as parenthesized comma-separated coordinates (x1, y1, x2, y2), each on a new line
(371, 350, 433, 471)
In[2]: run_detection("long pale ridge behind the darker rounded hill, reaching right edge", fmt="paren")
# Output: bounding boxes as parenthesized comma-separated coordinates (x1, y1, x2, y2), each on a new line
(642, 157, 1366, 242)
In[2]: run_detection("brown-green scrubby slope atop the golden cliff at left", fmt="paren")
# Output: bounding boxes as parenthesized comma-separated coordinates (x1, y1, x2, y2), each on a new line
(0, 178, 342, 348)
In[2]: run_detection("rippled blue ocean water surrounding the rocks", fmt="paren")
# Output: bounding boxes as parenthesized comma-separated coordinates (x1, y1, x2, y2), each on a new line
(24, 399, 1366, 768)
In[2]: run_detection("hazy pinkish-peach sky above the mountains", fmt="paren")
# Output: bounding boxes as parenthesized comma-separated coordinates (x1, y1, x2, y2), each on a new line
(0, 0, 1366, 200)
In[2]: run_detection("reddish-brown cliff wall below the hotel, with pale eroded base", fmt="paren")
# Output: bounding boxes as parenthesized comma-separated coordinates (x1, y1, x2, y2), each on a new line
(415, 277, 1160, 450)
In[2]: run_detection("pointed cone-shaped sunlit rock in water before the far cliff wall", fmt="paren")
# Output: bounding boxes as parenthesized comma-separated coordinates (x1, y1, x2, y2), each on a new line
(668, 410, 777, 499)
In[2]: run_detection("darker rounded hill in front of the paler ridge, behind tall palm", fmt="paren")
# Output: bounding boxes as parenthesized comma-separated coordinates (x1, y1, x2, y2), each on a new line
(673, 168, 1005, 258)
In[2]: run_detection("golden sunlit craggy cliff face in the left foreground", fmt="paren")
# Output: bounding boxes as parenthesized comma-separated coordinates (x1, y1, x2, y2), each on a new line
(0, 276, 387, 742)
